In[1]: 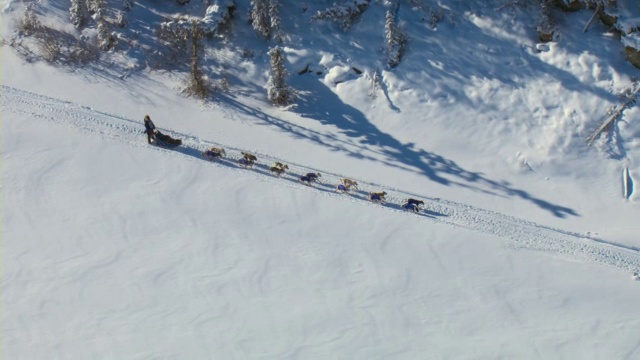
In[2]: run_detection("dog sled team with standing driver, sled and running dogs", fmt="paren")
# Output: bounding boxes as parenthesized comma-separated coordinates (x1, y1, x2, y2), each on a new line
(144, 115, 424, 213)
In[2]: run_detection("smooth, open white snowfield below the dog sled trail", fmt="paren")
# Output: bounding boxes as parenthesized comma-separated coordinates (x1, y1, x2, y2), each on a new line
(2, 88, 640, 359)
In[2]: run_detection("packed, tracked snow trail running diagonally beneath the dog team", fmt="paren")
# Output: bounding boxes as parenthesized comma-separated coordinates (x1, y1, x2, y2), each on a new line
(1, 86, 640, 271)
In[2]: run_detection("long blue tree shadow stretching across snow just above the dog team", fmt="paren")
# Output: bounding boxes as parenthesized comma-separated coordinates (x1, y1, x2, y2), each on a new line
(215, 86, 578, 218)
